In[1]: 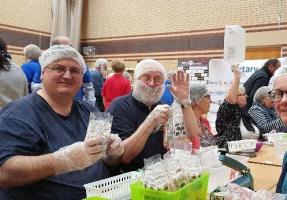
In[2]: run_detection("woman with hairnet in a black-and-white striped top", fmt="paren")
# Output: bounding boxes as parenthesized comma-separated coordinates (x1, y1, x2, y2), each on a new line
(248, 86, 284, 134)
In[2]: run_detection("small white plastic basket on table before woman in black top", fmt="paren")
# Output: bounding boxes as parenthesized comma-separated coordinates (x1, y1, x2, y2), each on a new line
(227, 139, 257, 152)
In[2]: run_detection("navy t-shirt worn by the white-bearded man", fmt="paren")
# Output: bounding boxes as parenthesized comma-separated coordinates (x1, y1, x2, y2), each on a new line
(107, 94, 166, 174)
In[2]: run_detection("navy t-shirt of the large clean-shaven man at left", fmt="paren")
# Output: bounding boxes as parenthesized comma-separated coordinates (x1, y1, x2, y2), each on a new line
(0, 93, 109, 200)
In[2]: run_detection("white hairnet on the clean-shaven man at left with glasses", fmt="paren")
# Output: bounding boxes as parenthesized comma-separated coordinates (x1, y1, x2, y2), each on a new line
(39, 45, 87, 73)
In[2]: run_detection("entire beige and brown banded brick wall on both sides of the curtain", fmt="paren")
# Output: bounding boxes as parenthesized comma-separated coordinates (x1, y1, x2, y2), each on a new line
(0, 0, 287, 70)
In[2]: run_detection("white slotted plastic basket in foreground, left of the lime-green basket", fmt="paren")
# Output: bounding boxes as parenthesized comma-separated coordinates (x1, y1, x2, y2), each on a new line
(84, 171, 141, 200)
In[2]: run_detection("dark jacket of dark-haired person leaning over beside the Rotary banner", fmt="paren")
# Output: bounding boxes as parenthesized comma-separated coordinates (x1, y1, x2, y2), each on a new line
(243, 67, 272, 110)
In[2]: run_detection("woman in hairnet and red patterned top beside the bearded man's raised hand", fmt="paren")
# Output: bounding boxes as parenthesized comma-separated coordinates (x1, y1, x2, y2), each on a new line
(190, 84, 217, 147)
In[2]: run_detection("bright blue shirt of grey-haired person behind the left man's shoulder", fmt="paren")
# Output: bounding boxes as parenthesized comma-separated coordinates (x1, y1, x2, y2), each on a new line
(22, 60, 41, 93)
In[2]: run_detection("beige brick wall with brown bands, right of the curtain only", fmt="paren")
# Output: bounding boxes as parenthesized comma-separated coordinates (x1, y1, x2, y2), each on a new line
(82, 0, 287, 70)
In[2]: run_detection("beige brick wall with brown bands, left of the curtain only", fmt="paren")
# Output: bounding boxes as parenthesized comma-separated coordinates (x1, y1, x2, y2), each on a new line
(0, 0, 52, 65)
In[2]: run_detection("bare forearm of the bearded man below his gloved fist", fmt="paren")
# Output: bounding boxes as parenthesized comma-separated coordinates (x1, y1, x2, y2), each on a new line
(122, 121, 154, 163)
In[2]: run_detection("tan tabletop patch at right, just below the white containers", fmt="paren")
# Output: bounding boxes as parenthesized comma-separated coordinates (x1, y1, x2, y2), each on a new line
(248, 144, 282, 167)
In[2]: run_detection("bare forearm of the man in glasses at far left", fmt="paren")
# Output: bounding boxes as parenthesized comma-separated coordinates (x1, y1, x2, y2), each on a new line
(0, 154, 57, 187)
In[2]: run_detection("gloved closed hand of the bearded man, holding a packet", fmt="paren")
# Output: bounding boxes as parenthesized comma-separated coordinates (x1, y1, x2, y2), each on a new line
(146, 104, 171, 127)
